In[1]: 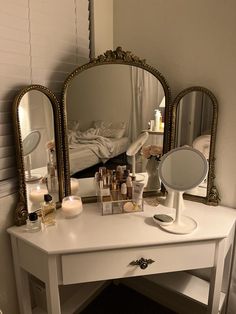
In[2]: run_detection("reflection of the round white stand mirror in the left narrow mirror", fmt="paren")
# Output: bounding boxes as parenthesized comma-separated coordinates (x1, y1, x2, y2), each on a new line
(22, 130, 42, 182)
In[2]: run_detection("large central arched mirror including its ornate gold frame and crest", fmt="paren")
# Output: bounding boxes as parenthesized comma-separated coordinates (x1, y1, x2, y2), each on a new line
(62, 47, 171, 201)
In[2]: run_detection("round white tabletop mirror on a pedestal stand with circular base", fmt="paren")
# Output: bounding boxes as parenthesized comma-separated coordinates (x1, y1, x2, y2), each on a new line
(159, 146, 208, 234)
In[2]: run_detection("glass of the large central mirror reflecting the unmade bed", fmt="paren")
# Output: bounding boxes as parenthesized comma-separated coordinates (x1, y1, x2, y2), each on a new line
(65, 64, 165, 196)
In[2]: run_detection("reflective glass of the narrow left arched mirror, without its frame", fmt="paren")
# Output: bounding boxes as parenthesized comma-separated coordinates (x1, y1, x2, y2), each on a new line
(19, 90, 58, 212)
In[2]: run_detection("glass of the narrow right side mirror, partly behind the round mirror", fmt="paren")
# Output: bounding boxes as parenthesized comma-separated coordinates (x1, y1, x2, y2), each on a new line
(175, 91, 213, 197)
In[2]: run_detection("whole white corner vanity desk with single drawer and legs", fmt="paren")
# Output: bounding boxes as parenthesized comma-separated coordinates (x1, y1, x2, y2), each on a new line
(8, 201, 236, 314)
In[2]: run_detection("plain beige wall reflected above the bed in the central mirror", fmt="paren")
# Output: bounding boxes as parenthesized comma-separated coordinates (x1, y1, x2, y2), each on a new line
(67, 65, 131, 130)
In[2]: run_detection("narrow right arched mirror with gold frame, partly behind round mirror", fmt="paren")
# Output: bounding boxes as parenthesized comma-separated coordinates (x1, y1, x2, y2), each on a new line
(171, 86, 220, 205)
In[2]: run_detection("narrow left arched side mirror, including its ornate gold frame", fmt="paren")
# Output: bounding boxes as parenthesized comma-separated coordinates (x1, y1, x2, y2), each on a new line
(13, 85, 64, 225)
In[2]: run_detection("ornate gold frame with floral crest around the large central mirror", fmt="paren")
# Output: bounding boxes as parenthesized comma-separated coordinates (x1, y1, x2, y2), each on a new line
(62, 47, 171, 202)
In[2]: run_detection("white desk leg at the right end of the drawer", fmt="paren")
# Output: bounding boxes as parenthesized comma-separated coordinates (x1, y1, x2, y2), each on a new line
(207, 239, 225, 314)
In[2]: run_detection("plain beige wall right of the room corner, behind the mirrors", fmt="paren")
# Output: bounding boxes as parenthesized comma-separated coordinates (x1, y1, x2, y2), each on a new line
(114, 0, 236, 207)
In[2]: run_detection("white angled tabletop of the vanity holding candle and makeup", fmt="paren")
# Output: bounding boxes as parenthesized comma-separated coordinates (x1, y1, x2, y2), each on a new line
(8, 201, 236, 254)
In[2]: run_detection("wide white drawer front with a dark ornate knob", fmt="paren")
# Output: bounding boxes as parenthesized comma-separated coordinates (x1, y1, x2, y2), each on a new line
(61, 241, 215, 284)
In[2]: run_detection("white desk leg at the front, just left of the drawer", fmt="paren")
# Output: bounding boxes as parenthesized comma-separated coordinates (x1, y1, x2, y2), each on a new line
(45, 255, 61, 314)
